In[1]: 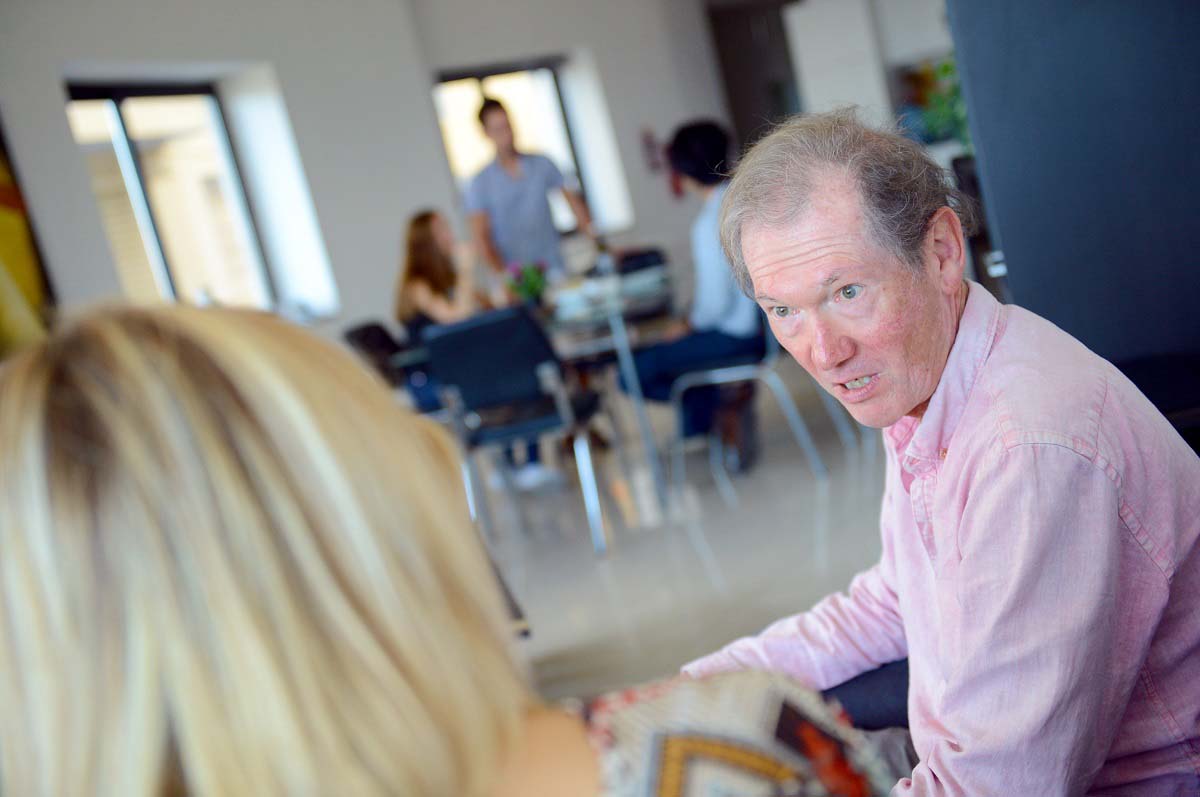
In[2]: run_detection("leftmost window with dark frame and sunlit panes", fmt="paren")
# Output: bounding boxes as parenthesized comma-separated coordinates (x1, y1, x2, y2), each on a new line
(67, 85, 275, 310)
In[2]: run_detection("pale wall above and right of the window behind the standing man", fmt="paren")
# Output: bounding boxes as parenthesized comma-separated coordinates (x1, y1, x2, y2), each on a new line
(414, 0, 727, 269)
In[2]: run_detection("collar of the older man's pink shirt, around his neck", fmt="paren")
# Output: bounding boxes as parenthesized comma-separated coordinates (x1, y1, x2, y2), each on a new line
(888, 282, 1003, 461)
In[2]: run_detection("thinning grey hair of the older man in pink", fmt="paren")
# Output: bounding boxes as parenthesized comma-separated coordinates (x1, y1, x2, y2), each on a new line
(721, 108, 976, 294)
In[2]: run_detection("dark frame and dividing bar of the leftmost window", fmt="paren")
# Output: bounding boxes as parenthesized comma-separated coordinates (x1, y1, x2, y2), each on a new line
(66, 82, 280, 304)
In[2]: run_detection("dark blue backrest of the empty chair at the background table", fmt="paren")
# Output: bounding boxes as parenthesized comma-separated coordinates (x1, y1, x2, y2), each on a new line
(424, 305, 558, 409)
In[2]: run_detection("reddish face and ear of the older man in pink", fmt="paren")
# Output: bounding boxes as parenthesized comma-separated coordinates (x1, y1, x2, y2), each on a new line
(742, 171, 964, 427)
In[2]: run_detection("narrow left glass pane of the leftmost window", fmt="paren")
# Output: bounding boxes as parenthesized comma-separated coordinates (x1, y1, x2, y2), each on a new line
(67, 100, 170, 301)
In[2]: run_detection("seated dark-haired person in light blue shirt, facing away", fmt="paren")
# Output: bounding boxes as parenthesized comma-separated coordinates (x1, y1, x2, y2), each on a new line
(635, 121, 763, 437)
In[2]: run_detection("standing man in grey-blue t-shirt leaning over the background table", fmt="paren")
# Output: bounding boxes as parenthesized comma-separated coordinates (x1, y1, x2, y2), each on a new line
(466, 97, 595, 281)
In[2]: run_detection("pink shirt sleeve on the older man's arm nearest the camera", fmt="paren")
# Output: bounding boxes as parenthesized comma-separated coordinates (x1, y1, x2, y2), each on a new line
(892, 444, 1168, 797)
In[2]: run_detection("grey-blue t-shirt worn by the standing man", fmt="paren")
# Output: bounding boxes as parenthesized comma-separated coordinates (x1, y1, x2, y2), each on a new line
(466, 155, 564, 275)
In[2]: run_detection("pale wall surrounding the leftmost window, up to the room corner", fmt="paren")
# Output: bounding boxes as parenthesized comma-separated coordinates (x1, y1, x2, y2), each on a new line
(0, 0, 454, 326)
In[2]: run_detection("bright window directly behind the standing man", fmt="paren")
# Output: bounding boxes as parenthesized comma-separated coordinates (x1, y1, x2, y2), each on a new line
(433, 60, 583, 233)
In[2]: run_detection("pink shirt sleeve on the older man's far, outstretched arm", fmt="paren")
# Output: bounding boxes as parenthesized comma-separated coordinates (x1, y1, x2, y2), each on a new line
(683, 441, 908, 689)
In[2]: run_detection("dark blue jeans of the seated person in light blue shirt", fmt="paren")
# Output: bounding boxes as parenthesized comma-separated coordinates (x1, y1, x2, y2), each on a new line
(620, 331, 766, 437)
